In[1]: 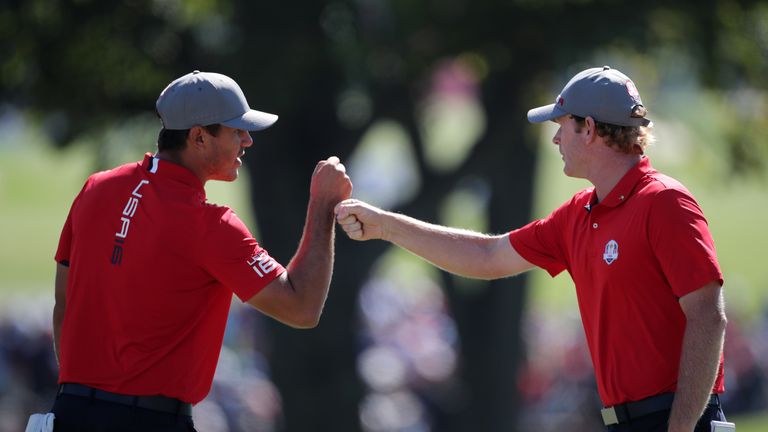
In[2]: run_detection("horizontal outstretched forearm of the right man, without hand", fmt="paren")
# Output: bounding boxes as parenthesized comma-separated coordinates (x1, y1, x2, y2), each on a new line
(382, 212, 505, 279)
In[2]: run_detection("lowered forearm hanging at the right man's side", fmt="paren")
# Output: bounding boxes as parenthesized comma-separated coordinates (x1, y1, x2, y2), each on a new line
(669, 315, 726, 432)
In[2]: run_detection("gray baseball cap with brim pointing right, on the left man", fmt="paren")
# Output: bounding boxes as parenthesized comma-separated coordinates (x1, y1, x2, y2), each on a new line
(155, 71, 277, 131)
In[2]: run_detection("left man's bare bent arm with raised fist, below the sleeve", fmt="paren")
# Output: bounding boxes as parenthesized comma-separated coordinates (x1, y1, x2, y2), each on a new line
(248, 157, 352, 328)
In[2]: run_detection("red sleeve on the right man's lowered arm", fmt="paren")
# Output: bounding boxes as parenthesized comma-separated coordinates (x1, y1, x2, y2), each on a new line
(648, 188, 723, 297)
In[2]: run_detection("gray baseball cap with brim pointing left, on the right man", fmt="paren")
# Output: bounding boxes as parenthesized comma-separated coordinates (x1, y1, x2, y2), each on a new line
(528, 66, 652, 126)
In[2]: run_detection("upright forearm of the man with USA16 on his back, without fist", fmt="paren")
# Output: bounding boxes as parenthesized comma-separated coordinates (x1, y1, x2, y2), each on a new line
(287, 202, 334, 326)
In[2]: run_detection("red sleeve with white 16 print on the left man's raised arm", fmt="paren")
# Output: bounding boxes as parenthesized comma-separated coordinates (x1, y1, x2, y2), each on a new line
(200, 208, 285, 302)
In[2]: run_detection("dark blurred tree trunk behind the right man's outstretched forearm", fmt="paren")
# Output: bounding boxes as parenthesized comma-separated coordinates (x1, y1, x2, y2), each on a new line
(417, 74, 536, 432)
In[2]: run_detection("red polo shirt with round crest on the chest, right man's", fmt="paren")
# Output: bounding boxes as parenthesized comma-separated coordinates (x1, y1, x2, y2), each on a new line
(509, 157, 723, 406)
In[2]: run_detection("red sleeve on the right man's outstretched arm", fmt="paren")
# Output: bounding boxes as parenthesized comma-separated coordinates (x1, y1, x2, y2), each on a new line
(509, 203, 568, 277)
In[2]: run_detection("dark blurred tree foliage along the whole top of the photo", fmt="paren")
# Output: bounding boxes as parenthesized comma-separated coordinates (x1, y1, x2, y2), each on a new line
(0, 0, 768, 171)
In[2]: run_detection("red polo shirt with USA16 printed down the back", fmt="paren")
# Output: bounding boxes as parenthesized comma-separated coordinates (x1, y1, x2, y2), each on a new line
(56, 154, 285, 403)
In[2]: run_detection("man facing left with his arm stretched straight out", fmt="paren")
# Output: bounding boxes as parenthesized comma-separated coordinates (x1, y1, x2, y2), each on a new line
(336, 66, 726, 432)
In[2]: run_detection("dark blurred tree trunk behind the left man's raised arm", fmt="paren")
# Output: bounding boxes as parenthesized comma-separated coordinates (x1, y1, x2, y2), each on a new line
(246, 68, 372, 431)
